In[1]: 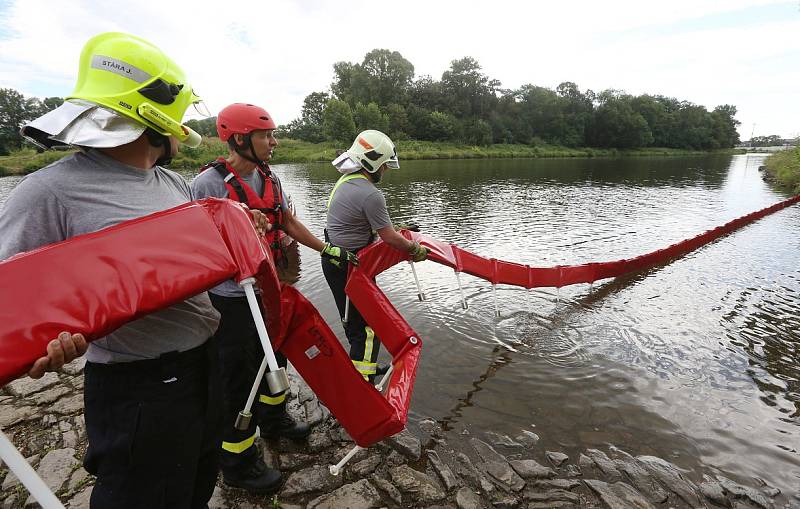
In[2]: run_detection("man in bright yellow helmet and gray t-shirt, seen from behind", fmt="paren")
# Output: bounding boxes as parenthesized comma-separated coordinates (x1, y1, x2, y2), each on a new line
(0, 33, 241, 509)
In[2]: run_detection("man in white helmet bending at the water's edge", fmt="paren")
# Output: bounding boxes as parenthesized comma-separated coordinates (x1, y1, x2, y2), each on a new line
(322, 130, 428, 382)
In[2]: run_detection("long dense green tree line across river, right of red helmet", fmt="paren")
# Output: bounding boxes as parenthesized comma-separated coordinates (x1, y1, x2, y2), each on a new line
(282, 49, 740, 150)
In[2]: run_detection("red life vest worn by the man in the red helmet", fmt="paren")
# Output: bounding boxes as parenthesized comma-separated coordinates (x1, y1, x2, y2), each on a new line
(200, 157, 286, 262)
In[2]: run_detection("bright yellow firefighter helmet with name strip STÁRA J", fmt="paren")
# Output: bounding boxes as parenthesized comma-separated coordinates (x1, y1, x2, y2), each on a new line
(67, 32, 200, 147)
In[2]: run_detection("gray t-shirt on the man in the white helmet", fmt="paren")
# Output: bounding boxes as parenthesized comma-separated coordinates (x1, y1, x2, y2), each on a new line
(327, 178, 392, 250)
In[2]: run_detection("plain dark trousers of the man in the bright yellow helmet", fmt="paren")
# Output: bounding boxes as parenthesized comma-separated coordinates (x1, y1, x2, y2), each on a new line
(84, 339, 222, 509)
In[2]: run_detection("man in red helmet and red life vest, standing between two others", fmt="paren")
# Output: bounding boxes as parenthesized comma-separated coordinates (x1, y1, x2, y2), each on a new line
(191, 103, 357, 493)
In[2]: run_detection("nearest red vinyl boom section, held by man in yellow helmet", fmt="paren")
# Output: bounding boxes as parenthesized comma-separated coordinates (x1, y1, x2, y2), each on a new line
(0, 198, 244, 386)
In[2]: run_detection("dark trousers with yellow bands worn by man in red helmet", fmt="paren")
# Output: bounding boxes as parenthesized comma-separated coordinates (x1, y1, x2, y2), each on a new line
(209, 293, 287, 469)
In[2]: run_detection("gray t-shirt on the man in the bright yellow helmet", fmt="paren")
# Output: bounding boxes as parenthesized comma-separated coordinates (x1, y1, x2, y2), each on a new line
(0, 150, 219, 363)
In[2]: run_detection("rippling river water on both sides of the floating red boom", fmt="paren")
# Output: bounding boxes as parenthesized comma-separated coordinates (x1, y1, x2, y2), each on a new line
(0, 155, 800, 497)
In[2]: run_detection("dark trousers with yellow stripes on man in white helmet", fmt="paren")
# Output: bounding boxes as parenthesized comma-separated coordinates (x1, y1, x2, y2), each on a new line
(322, 258, 381, 382)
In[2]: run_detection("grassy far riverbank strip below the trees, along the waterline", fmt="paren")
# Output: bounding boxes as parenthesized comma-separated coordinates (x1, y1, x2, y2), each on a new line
(0, 138, 731, 176)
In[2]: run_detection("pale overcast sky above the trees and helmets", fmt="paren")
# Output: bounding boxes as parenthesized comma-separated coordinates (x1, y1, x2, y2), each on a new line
(0, 0, 800, 139)
